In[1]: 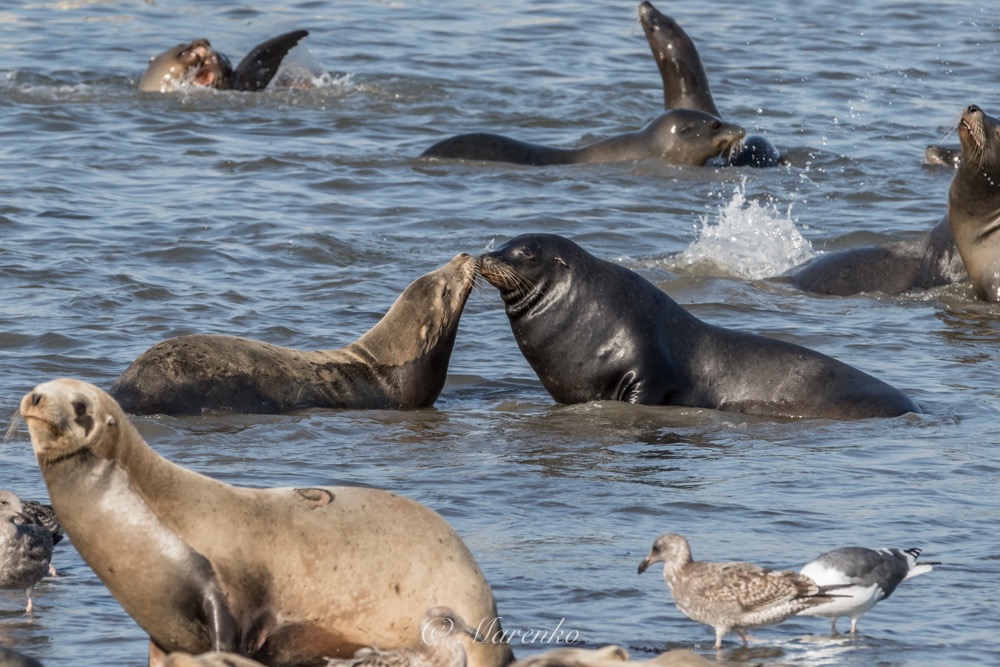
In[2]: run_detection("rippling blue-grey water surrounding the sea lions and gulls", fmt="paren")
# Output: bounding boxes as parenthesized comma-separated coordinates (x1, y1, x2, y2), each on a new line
(0, 0, 1000, 666)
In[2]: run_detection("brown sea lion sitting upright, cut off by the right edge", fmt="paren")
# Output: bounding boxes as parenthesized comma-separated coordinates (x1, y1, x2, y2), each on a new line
(948, 104, 1000, 301)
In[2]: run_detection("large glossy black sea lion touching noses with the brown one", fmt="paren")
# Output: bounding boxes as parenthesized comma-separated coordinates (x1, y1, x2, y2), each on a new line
(478, 234, 918, 419)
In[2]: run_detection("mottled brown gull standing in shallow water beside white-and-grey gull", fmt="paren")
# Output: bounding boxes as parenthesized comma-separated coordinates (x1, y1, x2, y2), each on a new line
(639, 533, 834, 649)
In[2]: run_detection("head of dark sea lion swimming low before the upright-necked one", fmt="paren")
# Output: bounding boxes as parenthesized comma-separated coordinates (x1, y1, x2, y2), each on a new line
(643, 109, 746, 166)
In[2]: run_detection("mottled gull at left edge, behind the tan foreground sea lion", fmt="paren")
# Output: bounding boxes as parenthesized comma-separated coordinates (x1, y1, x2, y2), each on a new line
(0, 491, 52, 614)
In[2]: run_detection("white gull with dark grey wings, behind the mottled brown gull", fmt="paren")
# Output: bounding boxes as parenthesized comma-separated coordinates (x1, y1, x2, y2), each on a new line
(799, 547, 940, 635)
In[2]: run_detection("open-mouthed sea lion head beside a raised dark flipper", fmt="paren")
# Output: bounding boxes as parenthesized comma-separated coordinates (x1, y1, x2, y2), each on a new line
(139, 39, 233, 93)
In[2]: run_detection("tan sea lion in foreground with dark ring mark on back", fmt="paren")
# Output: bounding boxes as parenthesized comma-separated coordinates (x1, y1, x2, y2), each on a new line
(20, 379, 512, 667)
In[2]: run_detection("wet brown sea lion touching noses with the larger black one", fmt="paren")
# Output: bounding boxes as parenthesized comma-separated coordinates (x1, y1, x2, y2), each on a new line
(110, 253, 476, 415)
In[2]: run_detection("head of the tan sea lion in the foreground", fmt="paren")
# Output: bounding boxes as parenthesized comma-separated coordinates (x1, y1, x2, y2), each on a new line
(21, 379, 128, 467)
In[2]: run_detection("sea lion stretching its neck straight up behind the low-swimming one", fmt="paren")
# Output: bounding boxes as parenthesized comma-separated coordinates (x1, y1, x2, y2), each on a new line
(639, 2, 781, 167)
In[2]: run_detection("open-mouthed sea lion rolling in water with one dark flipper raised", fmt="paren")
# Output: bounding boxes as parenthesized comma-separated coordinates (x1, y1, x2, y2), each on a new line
(139, 30, 309, 93)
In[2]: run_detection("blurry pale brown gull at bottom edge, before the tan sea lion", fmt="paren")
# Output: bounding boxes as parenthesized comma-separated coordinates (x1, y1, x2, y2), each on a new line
(327, 607, 484, 667)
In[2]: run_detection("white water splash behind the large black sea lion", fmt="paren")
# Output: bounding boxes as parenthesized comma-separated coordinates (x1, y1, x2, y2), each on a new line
(672, 179, 816, 280)
